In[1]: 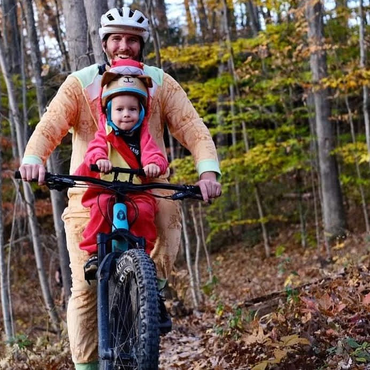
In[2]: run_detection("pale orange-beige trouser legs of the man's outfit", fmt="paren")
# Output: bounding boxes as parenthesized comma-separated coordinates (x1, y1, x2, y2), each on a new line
(63, 191, 181, 363)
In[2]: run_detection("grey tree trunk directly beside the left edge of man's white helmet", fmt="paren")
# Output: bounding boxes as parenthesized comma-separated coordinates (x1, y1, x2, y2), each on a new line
(84, 0, 108, 64)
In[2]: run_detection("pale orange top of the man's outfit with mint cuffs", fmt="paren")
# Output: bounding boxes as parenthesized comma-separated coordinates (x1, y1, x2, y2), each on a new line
(22, 64, 220, 208)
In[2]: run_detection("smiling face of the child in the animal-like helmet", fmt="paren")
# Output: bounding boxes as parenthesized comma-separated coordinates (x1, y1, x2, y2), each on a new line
(112, 95, 140, 130)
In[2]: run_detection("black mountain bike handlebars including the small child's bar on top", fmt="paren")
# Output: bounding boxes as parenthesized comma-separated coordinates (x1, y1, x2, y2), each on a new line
(14, 165, 203, 200)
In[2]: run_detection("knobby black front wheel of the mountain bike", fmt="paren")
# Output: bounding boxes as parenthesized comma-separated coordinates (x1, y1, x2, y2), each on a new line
(100, 249, 159, 370)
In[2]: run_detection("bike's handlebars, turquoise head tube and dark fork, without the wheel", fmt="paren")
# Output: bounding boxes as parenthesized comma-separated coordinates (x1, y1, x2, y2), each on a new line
(15, 165, 202, 366)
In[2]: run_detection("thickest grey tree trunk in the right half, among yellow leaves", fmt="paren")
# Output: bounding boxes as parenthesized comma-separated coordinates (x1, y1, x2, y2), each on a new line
(306, 0, 346, 251)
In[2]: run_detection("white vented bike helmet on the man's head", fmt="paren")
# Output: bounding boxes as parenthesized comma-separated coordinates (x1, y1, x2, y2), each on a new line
(99, 6, 149, 42)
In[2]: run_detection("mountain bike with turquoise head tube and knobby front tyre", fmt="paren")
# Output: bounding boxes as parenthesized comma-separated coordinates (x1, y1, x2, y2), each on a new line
(15, 166, 202, 370)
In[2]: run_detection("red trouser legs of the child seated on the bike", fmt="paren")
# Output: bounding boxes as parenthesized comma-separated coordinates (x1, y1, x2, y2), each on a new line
(80, 188, 157, 254)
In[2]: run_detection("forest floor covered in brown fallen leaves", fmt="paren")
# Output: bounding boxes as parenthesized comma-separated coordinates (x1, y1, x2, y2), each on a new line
(0, 224, 370, 370)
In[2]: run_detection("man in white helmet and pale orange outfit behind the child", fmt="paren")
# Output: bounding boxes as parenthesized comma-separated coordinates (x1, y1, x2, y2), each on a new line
(20, 7, 221, 370)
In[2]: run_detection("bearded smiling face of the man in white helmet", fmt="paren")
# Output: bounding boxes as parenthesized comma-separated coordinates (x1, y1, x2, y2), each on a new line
(103, 33, 141, 62)
